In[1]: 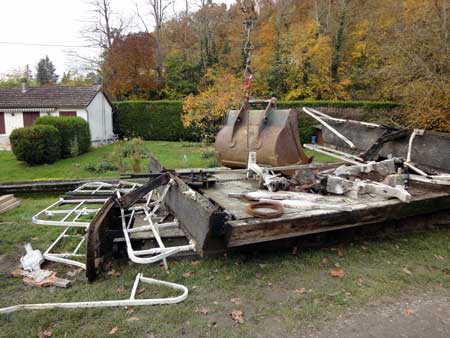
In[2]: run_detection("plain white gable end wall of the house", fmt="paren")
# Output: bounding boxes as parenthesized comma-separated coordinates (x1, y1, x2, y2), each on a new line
(87, 92, 114, 145)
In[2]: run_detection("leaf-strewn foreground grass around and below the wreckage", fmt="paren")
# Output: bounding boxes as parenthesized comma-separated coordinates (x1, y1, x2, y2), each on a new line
(0, 195, 450, 338)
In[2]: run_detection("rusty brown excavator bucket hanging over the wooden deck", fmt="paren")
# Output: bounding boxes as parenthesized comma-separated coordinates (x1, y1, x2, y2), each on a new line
(215, 99, 312, 168)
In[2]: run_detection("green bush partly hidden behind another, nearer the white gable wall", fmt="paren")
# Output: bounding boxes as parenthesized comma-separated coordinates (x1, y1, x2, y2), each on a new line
(35, 116, 91, 158)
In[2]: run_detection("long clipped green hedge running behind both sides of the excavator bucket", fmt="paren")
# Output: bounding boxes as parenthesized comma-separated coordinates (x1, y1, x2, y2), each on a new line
(114, 100, 400, 142)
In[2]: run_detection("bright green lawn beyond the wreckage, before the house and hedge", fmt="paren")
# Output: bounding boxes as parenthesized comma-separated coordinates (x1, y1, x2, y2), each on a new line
(0, 141, 333, 182)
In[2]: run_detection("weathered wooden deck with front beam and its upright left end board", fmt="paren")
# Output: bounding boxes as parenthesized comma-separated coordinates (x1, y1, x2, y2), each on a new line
(151, 157, 450, 254)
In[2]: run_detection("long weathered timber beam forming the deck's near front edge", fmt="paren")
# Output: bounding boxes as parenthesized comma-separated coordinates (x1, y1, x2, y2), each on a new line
(226, 193, 450, 247)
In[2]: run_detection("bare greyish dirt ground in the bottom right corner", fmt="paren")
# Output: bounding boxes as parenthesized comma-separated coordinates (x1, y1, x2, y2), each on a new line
(308, 290, 450, 338)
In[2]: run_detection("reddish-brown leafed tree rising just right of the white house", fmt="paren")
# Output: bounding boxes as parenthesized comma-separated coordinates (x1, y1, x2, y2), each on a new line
(102, 32, 158, 100)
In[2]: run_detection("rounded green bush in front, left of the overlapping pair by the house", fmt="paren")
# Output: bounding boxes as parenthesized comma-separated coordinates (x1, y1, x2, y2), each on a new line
(10, 125, 61, 165)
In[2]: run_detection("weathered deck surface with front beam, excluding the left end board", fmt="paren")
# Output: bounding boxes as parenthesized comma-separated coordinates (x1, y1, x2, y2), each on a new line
(201, 174, 450, 247)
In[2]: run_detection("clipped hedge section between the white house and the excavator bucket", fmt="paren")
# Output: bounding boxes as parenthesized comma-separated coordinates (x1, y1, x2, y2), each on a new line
(114, 100, 199, 141)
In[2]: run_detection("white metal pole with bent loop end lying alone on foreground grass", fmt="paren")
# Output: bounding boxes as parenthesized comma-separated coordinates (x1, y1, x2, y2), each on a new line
(0, 273, 189, 314)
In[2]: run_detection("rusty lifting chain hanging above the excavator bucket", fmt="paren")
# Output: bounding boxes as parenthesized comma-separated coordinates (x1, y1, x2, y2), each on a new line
(241, 0, 259, 102)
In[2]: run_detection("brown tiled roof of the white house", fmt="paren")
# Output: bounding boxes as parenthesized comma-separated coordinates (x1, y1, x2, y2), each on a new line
(0, 85, 101, 108)
